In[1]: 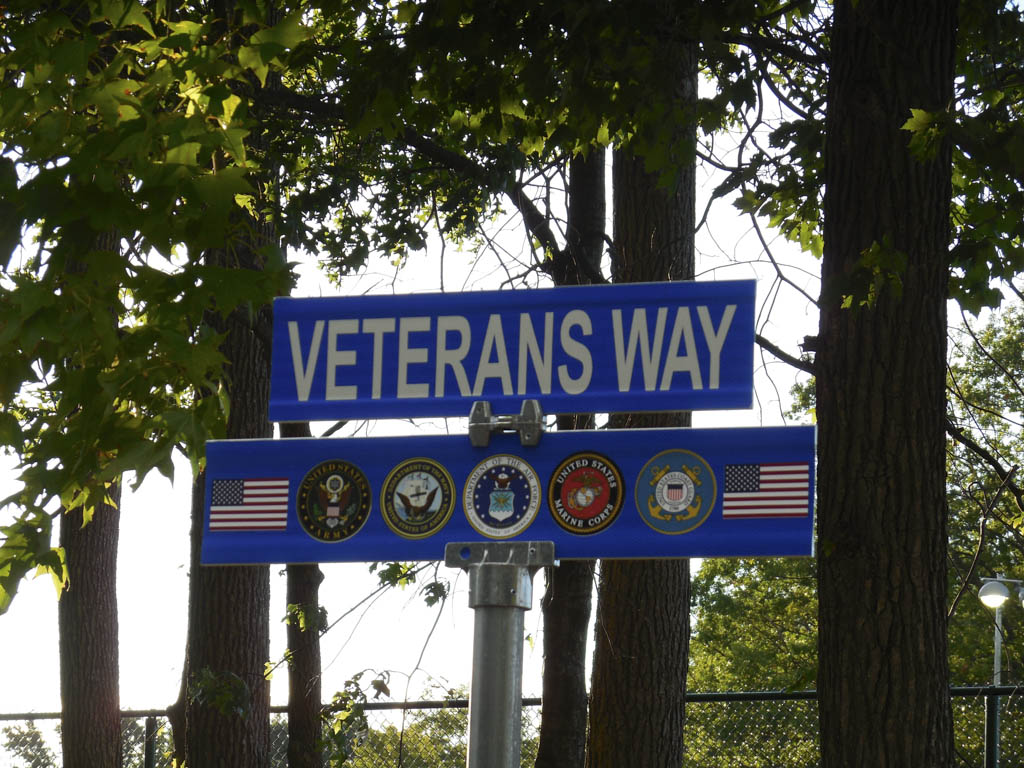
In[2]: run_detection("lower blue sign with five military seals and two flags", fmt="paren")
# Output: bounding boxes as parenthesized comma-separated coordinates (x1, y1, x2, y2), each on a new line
(202, 427, 815, 564)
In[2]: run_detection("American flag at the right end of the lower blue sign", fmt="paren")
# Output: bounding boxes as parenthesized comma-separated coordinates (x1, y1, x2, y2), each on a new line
(722, 462, 810, 518)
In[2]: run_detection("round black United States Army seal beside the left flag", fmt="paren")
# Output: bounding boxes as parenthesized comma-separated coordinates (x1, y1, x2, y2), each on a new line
(295, 461, 371, 542)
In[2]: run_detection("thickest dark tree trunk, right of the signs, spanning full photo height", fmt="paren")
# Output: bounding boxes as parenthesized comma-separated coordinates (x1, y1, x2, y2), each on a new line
(816, 0, 957, 768)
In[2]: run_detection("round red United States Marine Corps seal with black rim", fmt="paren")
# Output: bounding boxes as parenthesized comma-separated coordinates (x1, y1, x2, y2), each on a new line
(548, 453, 623, 534)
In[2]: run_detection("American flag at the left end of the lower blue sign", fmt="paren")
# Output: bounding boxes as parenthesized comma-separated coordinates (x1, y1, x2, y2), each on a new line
(210, 478, 288, 530)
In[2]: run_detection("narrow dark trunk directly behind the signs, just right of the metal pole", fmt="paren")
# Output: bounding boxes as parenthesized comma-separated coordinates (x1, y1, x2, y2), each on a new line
(536, 150, 605, 768)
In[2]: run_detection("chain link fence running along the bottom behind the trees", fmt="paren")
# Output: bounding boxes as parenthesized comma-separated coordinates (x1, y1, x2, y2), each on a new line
(0, 688, 1024, 768)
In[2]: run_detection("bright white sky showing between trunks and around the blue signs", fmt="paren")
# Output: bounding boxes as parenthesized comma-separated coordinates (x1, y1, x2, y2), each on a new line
(0, 156, 818, 713)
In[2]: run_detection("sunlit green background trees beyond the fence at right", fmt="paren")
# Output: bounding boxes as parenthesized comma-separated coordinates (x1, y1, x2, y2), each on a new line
(690, 300, 1024, 690)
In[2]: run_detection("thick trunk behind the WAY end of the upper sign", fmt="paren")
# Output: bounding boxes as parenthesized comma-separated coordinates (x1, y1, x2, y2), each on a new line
(587, 25, 696, 768)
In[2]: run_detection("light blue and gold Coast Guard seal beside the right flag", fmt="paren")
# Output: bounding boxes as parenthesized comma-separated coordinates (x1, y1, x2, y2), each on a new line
(635, 451, 718, 534)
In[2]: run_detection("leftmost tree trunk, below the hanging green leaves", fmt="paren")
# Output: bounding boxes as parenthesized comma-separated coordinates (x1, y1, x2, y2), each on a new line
(57, 483, 121, 768)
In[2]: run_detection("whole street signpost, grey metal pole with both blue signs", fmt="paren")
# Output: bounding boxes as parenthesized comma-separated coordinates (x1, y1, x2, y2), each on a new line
(202, 281, 815, 768)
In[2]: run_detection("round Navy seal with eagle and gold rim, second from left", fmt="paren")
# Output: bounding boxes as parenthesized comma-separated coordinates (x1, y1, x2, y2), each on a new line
(381, 459, 455, 539)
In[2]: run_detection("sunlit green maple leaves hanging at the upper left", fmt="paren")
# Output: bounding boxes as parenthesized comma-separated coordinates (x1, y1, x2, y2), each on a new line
(0, 0, 305, 612)
